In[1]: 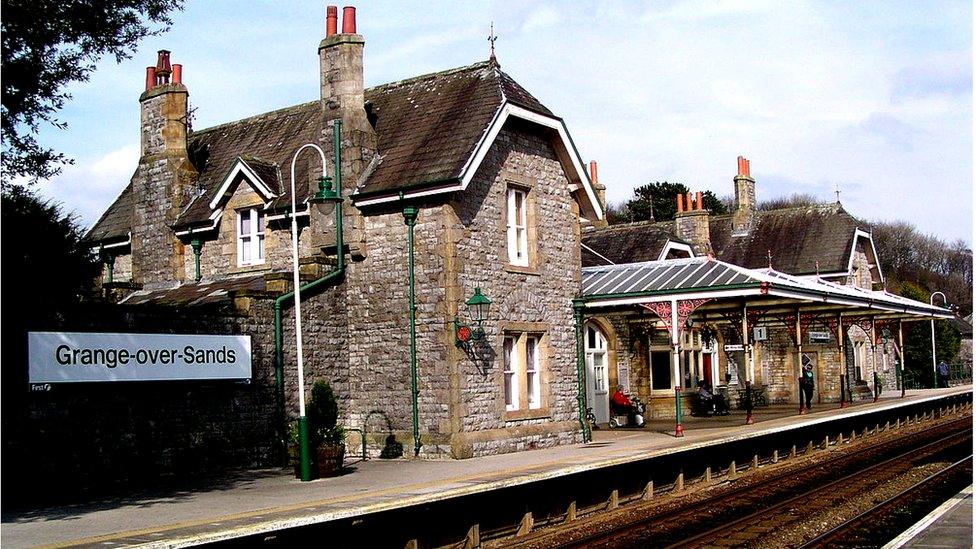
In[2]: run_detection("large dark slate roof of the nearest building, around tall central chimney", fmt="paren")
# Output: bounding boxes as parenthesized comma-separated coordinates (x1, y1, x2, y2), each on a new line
(87, 61, 557, 242)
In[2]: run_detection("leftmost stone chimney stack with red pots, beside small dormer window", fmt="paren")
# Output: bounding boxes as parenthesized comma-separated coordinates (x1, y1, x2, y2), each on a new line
(131, 50, 197, 287)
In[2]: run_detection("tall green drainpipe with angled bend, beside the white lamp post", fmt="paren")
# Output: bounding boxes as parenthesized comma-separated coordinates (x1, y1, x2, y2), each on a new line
(274, 120, 346, 458)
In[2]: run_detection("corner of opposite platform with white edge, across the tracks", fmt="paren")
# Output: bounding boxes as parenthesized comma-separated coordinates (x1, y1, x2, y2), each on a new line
(883, 485, 973, 549)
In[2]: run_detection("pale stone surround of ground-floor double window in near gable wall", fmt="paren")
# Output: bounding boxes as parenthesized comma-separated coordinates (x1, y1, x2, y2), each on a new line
(498, 322, 552, 421)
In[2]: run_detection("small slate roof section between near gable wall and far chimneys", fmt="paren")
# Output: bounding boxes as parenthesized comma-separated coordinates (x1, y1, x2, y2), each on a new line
(581, 221, 685, 267)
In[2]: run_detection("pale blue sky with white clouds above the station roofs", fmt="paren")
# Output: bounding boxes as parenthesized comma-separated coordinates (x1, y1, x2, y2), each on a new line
(26, 0, 973, 247)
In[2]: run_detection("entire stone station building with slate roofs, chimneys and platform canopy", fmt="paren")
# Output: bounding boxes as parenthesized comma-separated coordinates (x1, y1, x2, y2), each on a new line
(19, 7, 946, 492)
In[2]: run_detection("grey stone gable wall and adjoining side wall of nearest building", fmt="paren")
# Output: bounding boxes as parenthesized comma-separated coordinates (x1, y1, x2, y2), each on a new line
(347, 121, 580, 458)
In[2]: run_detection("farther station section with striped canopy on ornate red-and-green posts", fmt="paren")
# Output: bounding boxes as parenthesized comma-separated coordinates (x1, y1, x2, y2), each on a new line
(577, 157, 952, 422)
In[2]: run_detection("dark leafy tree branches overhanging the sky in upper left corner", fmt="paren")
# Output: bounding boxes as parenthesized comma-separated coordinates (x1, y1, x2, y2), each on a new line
(0, 0, 183, 186)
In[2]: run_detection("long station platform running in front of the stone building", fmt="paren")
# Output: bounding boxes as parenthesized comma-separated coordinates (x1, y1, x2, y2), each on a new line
(0, 385, 972, 548)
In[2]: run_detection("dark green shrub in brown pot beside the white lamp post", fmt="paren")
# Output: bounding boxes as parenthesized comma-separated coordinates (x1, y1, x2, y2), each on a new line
(306, 380, 346, 477)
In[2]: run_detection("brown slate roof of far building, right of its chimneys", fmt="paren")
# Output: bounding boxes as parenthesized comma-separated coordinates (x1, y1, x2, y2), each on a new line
(709, 203, 858, 275)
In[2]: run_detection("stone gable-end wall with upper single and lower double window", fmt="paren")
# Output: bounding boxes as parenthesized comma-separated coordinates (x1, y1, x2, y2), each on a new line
(450, 123, 581, 455)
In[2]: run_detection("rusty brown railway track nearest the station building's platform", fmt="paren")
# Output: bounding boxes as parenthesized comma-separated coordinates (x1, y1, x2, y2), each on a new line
(511, 414, 972, 547)
